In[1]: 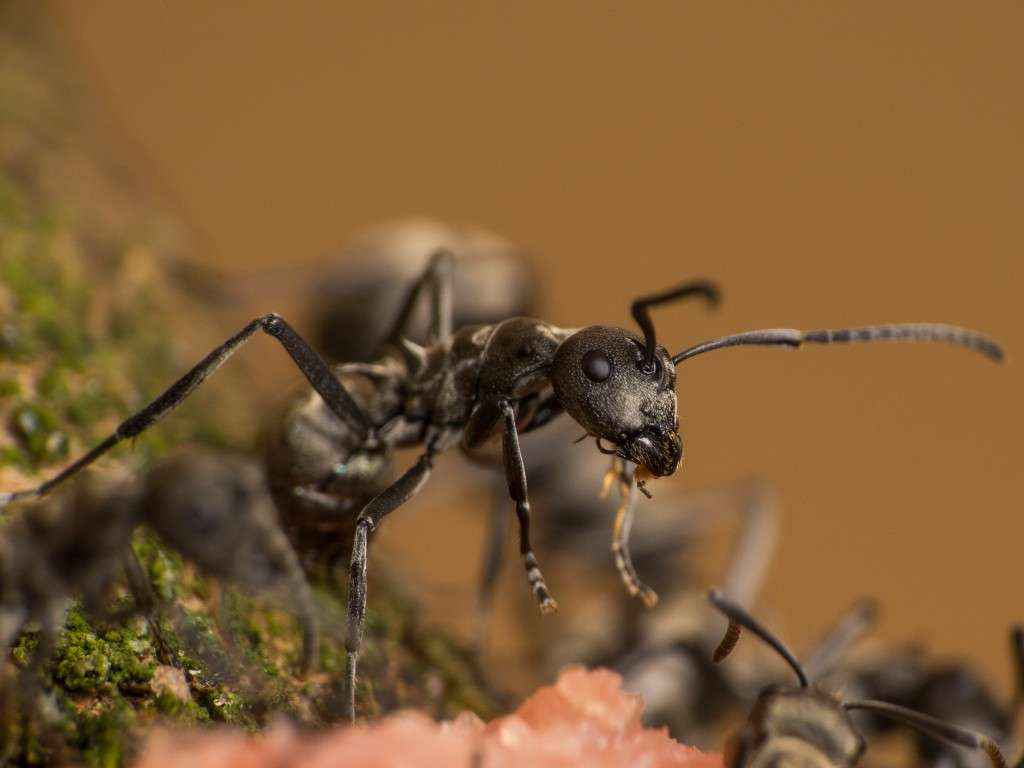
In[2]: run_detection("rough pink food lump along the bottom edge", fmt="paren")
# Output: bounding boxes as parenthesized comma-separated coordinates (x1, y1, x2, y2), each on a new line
(136, 667, 722, 768)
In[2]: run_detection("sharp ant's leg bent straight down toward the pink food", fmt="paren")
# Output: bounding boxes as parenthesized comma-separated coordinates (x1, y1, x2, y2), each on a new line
(345, 445, 434, 723)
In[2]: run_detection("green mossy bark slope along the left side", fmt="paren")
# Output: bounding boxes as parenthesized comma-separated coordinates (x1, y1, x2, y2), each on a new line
(0, 2, 498, 766)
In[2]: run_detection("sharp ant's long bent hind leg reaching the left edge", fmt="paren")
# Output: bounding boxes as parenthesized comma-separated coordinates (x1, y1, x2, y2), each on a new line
(0, 314, 373, 508)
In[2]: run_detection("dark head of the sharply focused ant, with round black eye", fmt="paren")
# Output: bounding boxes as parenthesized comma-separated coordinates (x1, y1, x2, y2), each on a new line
(551, 326, 683, 477)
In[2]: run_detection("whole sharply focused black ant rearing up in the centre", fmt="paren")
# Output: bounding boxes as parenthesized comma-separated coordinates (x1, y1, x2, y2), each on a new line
(0, 252, 1002, 718)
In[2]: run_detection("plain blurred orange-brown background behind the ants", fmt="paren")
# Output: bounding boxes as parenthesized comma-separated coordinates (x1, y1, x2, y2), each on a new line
(55, 0, 1024, 688)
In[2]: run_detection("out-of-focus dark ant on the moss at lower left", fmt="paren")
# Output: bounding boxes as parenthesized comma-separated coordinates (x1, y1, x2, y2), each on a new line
(0, 452, 318, 669)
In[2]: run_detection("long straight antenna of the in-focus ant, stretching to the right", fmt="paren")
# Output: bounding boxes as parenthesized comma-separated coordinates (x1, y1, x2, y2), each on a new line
(672, 323, 1005, 366)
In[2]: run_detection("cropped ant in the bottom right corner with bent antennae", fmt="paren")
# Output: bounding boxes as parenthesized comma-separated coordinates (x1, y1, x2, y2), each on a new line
(709, 590, 1007, 768)
